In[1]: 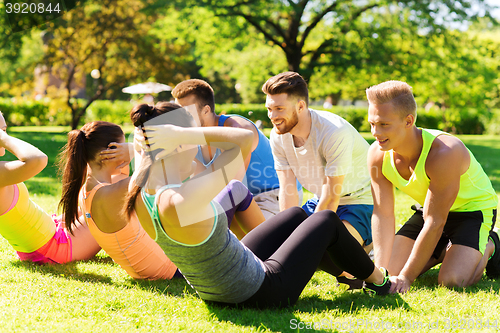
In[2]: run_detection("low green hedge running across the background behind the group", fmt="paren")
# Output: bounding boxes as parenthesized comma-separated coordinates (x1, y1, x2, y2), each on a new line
(0, 98, 500, 134)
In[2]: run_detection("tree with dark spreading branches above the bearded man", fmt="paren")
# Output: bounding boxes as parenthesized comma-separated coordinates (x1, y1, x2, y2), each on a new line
(162, 0, 498, 80)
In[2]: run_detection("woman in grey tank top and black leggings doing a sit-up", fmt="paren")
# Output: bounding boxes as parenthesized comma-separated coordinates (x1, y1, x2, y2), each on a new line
(125, 104, 390, 307)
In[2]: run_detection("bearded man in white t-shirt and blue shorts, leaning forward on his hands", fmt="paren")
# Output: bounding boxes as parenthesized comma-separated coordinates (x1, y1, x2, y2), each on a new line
(262, 72, 373, 252)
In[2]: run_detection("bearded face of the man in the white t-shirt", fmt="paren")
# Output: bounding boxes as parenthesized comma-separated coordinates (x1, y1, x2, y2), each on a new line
(266, 94, 299, 134)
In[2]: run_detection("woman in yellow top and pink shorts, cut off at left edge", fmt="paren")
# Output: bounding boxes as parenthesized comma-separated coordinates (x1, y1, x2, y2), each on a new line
(0, 113, 100, 264)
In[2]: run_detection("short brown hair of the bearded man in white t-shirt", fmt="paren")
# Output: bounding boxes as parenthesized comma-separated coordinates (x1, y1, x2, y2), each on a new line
(262, 72, 309, 105)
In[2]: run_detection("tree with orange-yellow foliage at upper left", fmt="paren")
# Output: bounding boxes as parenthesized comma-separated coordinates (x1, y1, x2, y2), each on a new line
(45, 0, 188, 129)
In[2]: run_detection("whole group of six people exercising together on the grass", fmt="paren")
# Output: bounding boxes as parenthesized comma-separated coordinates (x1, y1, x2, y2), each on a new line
(0, 72, 500, 308)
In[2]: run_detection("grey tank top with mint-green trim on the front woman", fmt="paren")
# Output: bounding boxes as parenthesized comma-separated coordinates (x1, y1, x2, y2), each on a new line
(141, 185, 265, 303)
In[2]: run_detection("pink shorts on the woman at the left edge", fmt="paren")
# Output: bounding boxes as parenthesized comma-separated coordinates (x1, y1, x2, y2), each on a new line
(17, 214, 73, 264)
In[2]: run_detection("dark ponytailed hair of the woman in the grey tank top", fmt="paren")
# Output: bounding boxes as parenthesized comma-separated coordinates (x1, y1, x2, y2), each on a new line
(123, 102, 194, 216)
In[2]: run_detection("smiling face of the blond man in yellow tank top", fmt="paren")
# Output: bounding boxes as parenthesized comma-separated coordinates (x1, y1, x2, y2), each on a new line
(368, 103, 409, 151)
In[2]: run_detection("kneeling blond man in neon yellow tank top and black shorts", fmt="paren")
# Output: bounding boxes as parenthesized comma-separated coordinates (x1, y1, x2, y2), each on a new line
(366, 81, 500, 292)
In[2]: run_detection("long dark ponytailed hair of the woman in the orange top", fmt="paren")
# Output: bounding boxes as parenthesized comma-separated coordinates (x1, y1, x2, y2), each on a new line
(58, 121, 123, 233)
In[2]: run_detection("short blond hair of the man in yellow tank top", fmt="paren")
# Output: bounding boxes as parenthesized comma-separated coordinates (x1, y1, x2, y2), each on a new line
(366, 80, 417, 117)
